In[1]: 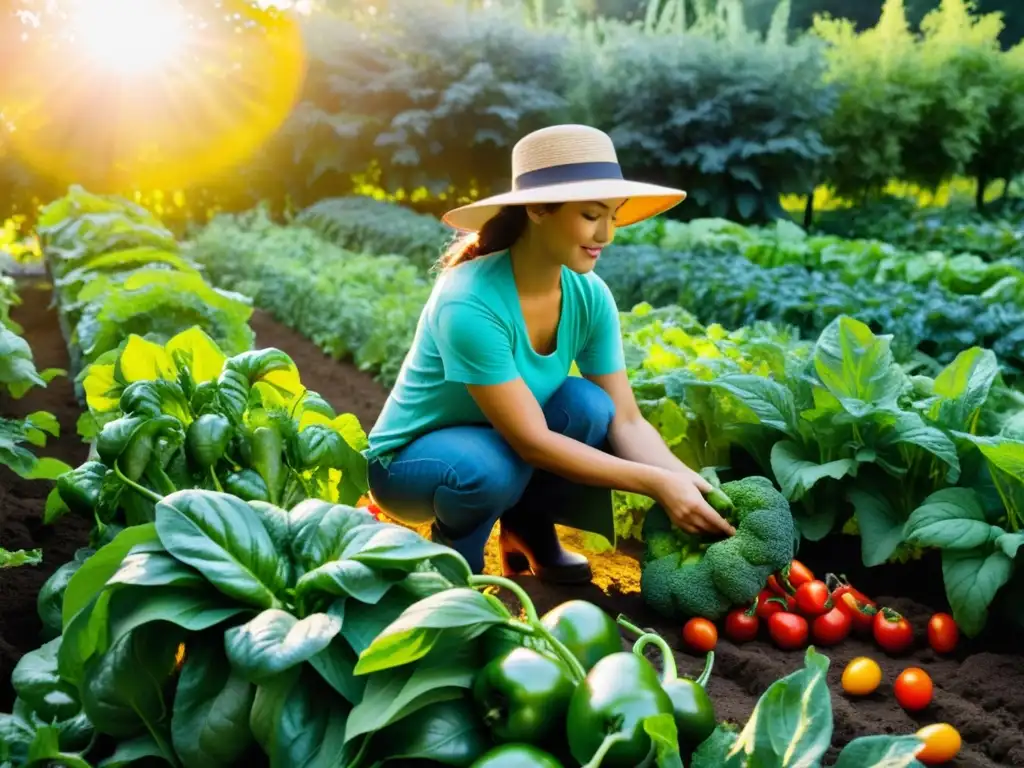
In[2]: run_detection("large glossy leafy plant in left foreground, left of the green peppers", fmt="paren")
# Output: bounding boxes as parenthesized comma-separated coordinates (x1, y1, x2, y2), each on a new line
(47, 490, 469, 766)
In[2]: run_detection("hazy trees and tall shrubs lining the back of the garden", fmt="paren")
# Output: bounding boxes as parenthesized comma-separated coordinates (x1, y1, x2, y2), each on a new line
(0, 0, 1024, 228)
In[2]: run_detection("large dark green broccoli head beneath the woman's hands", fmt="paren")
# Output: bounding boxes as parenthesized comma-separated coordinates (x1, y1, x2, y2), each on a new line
(640, 477, 794, 620)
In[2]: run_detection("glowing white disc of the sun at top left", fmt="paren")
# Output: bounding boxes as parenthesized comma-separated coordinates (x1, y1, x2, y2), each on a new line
(72, 0, 187, 75)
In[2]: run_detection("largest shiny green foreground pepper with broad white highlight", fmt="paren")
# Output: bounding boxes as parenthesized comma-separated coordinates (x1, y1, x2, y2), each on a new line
(566, 651, 673, 768)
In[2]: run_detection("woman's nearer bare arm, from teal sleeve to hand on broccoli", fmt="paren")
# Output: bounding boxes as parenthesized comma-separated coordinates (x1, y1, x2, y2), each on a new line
(468, 379, 735, 535)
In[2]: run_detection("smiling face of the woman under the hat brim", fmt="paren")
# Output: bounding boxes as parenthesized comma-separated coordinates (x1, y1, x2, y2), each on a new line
(528, 199, 626, 274)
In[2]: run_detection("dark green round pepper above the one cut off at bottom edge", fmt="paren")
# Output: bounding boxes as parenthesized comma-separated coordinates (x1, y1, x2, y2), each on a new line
(473, 648, 575, 743)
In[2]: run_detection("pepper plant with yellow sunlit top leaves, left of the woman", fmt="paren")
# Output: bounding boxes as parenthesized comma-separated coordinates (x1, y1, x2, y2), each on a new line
(46, 328, 367, 528)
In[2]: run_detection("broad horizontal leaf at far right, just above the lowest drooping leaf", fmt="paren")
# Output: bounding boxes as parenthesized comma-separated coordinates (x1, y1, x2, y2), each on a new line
(904, 487, 1002, 550)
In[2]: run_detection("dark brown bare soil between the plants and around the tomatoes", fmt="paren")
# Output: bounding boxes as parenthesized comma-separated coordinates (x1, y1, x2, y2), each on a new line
(0, 288, 1024, 768)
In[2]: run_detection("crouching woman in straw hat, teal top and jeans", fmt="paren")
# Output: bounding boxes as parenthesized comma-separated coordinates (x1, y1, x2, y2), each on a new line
(367, 125, 735, 583)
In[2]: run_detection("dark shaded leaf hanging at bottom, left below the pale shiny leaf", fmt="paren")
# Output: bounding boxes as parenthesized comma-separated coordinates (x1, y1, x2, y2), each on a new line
(171, 636, 256, 768)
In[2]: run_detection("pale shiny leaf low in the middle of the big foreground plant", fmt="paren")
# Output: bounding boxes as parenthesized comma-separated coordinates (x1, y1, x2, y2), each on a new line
(224, 608, 341, 683)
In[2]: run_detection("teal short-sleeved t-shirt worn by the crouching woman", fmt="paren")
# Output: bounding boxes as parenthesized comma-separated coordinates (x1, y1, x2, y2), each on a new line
(366, 251, 625, 463)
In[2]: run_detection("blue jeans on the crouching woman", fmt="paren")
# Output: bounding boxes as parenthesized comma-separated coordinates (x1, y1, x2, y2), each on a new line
(369, 377, 615, 573)
